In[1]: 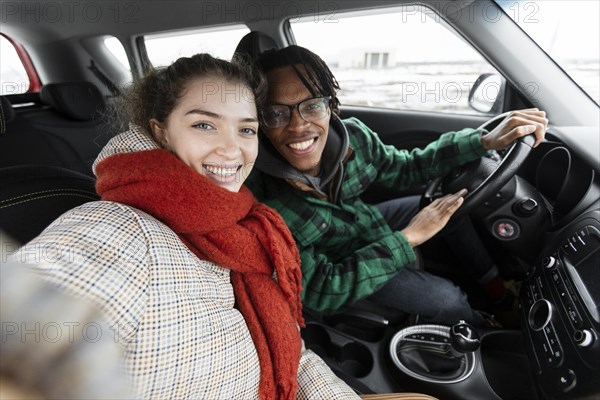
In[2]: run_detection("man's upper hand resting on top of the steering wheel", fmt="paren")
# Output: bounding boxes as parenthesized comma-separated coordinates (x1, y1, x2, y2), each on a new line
(481, 108, 548, 150)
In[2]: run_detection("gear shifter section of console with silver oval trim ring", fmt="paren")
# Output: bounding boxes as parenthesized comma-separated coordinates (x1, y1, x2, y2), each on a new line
(389, 322, 538, 400)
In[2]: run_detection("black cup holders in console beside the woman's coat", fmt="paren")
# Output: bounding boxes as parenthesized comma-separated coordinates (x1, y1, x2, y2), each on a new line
(302, 324, 374, 378)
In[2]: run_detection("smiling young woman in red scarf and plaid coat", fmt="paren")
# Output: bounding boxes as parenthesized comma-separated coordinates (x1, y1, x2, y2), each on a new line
(9, 54, 438, 399)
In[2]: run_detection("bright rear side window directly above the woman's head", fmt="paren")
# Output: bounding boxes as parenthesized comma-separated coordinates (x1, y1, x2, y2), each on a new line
(144, 25, 250, 67)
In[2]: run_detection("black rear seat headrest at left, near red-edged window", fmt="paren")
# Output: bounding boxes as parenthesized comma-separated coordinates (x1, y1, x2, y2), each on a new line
(40, 82, 104, 121)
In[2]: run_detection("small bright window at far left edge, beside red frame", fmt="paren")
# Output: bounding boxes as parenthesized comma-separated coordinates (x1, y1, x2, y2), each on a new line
(0, 35, 36, 96)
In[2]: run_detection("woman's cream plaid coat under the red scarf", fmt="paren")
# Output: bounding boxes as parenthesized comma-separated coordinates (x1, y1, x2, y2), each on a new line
(11, 130, 357, 400)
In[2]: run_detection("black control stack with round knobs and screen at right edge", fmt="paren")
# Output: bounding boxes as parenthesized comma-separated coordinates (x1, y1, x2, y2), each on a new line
(521, 211, 600, 399)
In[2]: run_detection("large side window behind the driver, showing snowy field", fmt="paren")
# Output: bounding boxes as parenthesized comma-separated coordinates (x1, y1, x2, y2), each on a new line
(290, 6, 500, 114)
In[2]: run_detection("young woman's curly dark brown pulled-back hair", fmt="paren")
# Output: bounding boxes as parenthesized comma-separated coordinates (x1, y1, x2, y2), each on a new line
(119, 53, 267, 139)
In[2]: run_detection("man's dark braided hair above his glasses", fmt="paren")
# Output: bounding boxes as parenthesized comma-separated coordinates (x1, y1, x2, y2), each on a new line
(258, 45, 340, 114)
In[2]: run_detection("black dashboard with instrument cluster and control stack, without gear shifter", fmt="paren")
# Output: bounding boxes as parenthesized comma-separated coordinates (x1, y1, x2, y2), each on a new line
(478, 128, 600, 399)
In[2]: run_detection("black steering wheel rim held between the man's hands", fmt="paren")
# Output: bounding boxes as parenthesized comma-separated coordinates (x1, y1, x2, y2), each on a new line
(421, 112, 535, 219)
